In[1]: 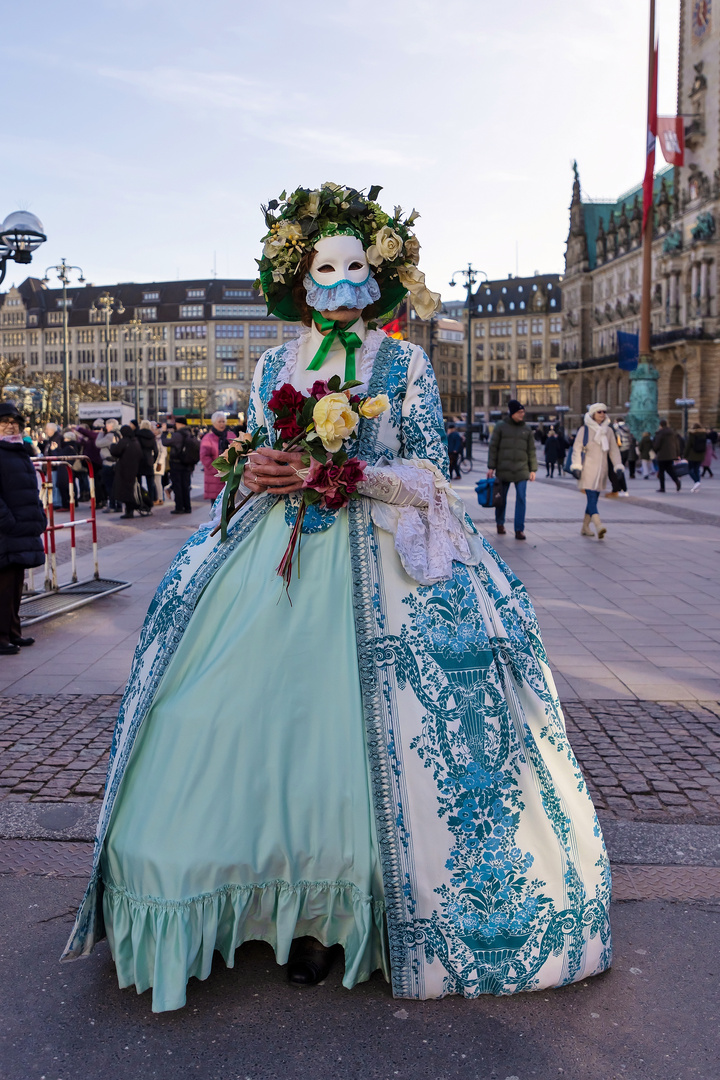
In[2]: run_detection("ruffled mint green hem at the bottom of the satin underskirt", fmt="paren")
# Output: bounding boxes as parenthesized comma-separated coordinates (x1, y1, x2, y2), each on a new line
(103, 880, 390, 1012)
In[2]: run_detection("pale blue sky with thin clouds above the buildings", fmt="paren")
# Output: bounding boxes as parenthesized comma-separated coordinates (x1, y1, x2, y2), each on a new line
(0, 0, 679, 299)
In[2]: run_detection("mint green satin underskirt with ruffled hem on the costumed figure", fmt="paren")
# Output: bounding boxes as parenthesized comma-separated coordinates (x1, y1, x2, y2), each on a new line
(101, 502, 390, 1012)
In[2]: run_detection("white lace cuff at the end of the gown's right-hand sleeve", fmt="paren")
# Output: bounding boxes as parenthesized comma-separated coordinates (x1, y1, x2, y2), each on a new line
(357, 458, 483, 585)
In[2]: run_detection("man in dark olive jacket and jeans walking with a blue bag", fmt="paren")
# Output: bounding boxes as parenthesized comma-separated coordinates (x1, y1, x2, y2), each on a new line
(488, 399, 538, 540)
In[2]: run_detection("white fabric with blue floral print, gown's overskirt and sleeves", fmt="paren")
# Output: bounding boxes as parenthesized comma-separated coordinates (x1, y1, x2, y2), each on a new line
(65, 338, 611, 998)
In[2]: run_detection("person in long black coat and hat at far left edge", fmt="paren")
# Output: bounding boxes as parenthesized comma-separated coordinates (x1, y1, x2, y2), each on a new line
(0, 402, 46, 656)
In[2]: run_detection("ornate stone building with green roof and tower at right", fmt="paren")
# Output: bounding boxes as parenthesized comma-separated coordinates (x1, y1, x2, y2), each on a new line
(558, 0, 720, 429)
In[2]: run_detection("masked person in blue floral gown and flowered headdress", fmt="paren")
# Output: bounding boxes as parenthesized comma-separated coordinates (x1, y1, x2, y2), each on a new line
(64, 184, 611, 1011)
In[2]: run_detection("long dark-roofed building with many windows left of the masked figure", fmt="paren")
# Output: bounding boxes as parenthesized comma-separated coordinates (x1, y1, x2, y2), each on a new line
(0, 278, 299, 418)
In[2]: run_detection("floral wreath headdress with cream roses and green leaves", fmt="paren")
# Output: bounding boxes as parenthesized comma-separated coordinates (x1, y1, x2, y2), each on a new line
(256, 184, 440, 321)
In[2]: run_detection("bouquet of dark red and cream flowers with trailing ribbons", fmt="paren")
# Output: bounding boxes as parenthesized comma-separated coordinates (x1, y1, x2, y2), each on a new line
(213, 375, 390, 589)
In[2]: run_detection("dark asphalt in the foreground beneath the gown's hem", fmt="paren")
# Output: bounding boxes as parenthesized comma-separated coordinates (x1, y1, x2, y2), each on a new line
(0, 875, 720, 1080)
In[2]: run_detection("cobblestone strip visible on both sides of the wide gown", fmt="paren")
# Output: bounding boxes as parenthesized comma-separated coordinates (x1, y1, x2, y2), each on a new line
(0, 694, 720, 824)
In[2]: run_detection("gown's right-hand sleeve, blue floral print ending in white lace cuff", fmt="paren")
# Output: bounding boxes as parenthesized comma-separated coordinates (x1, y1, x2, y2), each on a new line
(357, 346, 483, 585)
